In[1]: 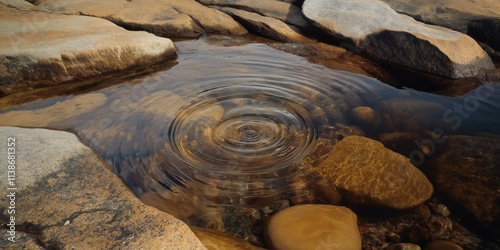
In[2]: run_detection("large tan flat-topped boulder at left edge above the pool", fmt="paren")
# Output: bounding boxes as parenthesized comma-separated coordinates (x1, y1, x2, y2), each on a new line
(0, 3, 176, 93)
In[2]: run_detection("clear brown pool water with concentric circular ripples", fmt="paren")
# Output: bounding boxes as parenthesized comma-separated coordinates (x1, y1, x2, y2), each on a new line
(0, 35, 500, 238)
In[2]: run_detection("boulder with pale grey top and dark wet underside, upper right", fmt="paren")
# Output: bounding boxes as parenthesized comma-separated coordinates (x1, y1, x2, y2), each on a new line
(302, 0, 494, 78)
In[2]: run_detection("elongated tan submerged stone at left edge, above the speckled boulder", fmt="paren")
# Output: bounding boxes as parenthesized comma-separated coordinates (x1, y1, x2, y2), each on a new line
(0, 93, 107, 127)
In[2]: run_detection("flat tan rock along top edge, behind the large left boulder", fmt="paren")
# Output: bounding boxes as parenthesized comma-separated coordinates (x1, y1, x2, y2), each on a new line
(37, 0, 246, 38)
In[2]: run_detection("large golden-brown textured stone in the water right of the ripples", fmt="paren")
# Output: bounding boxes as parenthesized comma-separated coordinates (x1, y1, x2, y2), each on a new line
(318, 136, 433, 209)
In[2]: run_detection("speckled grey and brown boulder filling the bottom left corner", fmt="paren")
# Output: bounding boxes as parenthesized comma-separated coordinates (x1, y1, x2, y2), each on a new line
(0, 127, 206, 249)
